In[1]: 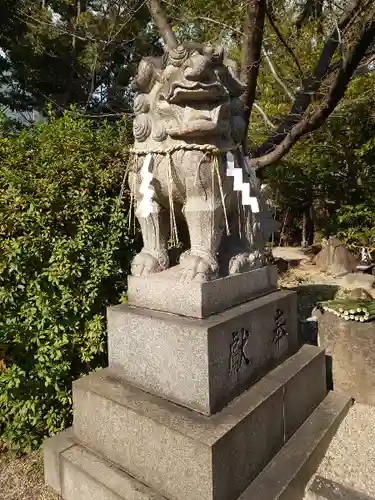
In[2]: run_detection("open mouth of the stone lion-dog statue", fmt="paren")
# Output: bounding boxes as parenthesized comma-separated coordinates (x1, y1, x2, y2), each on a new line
(167, 82, 228, 104)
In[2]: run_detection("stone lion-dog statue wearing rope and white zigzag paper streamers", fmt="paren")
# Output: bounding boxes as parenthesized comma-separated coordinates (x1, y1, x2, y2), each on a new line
(128, 45, 273, 281)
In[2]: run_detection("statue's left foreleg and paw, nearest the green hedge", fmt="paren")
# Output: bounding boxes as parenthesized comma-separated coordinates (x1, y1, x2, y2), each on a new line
(129, 173, 169, 276)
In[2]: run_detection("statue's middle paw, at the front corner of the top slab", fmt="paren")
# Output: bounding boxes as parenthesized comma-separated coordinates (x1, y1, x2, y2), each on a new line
(180, 251, 218, 283)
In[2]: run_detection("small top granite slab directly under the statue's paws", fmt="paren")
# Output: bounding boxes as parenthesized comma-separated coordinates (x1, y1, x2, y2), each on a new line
(127, 266, 277, 318)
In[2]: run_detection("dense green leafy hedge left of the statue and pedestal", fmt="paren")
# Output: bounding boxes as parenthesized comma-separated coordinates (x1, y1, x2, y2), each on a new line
(0, 114, 135, 451)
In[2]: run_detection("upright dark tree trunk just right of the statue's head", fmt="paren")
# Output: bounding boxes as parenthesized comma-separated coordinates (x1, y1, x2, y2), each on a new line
(241, 0, 266, 150)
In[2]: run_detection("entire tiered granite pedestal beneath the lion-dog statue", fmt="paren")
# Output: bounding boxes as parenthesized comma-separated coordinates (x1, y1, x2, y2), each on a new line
(45, 268, 347, 500)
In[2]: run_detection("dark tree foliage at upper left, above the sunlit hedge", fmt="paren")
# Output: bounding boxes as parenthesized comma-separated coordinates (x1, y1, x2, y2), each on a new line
(0, 0, 160, 116)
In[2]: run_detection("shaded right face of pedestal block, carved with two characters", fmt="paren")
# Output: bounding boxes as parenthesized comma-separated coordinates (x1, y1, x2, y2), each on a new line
(209, 291, 299, 414)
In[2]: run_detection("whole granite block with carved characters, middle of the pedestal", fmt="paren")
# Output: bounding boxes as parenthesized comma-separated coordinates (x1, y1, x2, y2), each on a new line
(108, 291, 298, 415)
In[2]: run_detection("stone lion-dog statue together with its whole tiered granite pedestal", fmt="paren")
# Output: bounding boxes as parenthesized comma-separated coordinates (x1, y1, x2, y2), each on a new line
(45, 45, 347, 500)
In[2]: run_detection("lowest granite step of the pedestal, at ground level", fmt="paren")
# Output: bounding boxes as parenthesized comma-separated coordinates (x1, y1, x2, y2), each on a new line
(44, 392, 352, 500)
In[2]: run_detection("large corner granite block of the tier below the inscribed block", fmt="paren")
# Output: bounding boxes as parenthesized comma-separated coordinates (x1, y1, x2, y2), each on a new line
(73, 346, 321, 500)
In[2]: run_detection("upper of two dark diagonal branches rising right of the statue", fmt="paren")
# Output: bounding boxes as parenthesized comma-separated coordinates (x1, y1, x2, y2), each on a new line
(254, 0, 363, 157)
